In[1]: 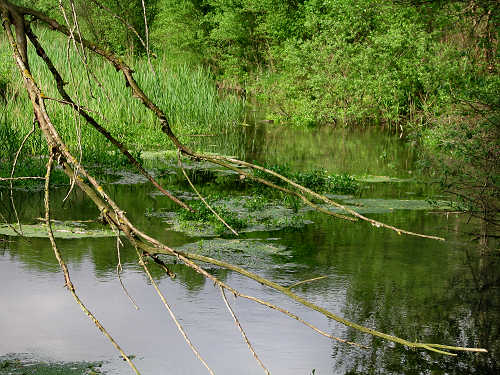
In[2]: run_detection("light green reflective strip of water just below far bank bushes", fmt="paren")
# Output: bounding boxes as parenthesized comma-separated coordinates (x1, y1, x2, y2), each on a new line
(245, 124, 414, 176)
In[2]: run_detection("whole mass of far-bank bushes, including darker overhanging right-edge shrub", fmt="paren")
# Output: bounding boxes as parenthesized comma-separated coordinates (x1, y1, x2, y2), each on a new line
(149, 0, 500, 228)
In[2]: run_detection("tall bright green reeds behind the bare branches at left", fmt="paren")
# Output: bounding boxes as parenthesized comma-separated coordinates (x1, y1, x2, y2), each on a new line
(0, 30, 245, 174)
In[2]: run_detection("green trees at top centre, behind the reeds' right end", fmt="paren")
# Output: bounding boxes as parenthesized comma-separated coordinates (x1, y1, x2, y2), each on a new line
(152, 0, 302, 78)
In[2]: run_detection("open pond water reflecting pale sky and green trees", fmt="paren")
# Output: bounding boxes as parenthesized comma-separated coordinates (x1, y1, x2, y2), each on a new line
(0, 125, 500, 375)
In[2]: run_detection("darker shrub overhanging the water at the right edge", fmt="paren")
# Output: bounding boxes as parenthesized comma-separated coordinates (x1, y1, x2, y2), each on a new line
(416, 85, 500, 226)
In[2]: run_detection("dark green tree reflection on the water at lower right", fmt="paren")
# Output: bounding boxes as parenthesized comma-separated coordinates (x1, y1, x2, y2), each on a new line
(260, 211, 500, 374)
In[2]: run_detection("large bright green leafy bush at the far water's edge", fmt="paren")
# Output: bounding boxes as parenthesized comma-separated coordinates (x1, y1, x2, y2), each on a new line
(254, 0, 460, 125)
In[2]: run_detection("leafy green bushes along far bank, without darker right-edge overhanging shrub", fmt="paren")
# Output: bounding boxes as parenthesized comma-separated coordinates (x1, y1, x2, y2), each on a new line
(147, 0, 499, 128)
